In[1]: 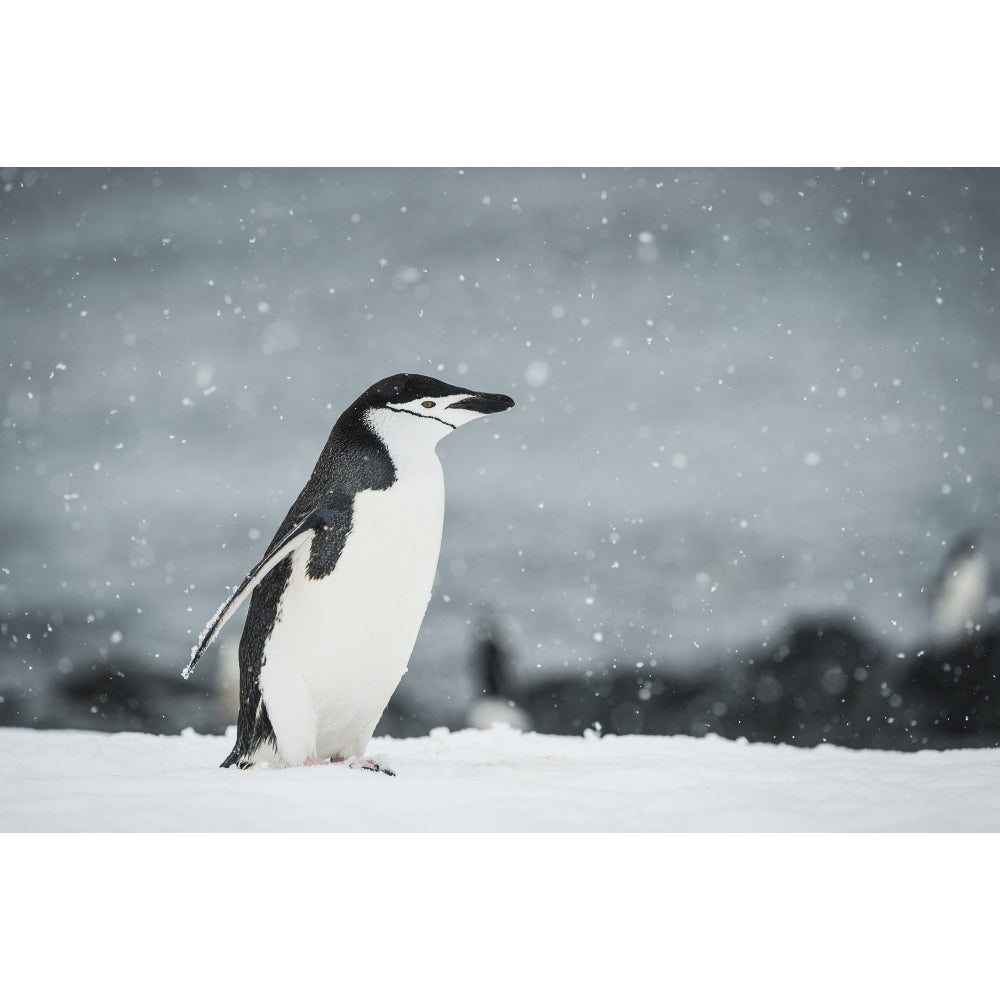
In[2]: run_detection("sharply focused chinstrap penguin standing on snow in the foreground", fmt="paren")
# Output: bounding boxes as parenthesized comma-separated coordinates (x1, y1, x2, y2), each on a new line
(183, 374, 514, 773)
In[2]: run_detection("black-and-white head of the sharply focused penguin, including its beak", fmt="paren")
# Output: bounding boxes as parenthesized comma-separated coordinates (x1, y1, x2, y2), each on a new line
(355, 374, 514, 441)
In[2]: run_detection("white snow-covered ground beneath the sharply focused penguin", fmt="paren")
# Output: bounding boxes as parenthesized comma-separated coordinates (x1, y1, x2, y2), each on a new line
(0, 728, 1000, 833)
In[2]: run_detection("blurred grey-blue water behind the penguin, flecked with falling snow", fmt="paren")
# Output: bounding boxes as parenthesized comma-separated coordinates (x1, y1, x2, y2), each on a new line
(0, 169, 1000, 724)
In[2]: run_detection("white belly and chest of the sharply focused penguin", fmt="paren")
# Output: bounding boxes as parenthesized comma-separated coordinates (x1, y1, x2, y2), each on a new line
(260, 464, 444, 763)
